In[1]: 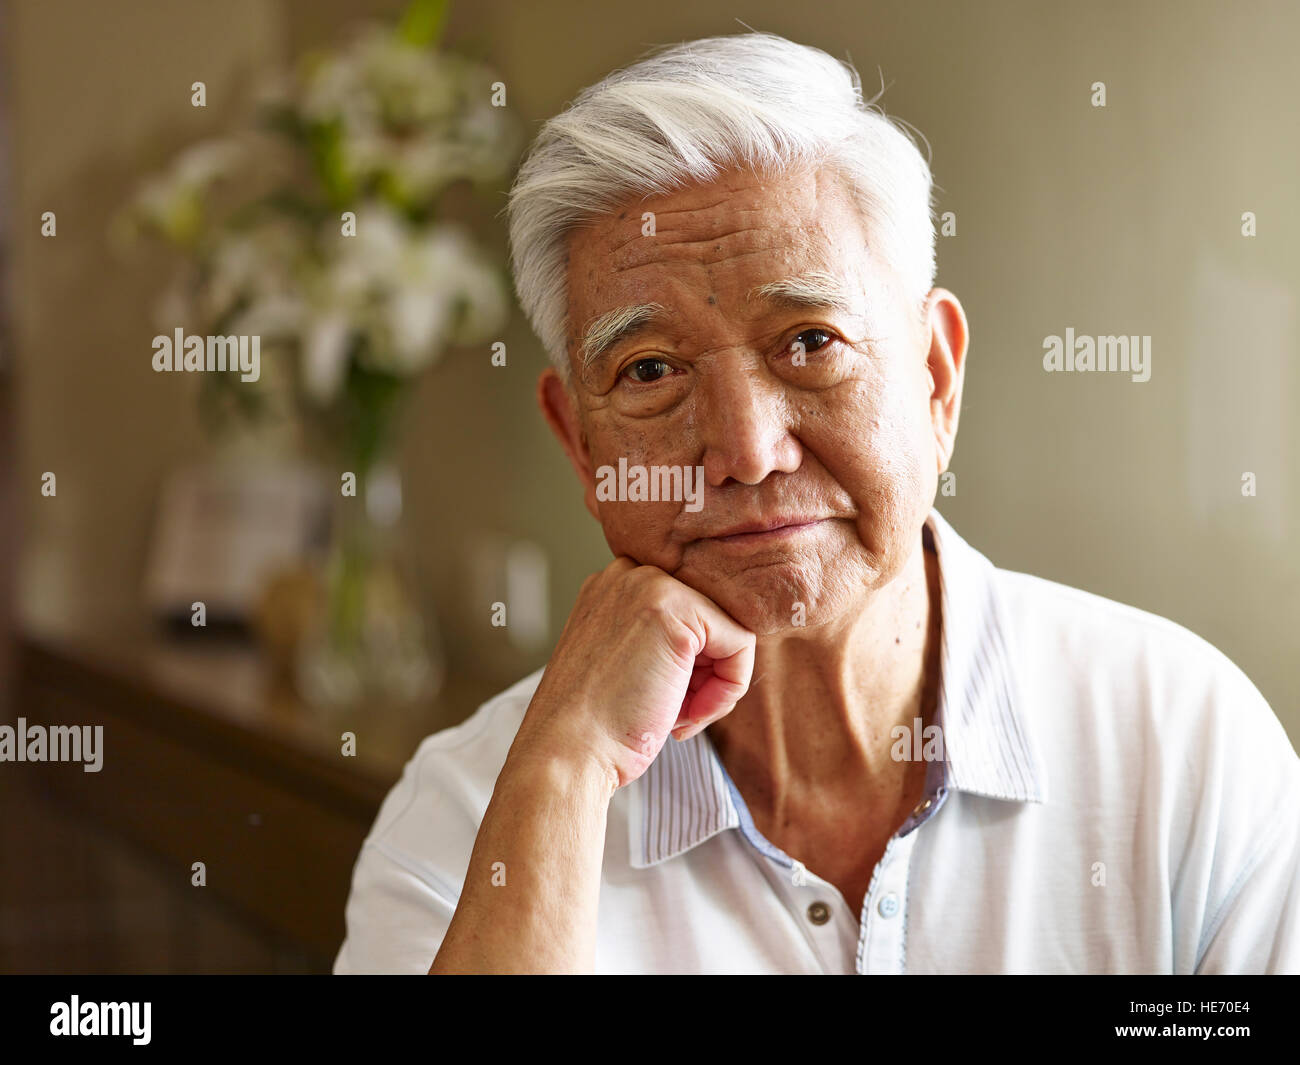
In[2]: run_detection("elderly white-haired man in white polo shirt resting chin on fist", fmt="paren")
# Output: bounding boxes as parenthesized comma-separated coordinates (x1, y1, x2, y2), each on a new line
(335, 34, 1300, 973)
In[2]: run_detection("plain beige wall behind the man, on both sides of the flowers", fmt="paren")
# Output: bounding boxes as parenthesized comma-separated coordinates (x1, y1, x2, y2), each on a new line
(9, 0, 1300, 737)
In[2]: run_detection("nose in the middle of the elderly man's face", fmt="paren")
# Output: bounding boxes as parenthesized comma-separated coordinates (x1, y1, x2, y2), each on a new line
(696, 360, 801, 488)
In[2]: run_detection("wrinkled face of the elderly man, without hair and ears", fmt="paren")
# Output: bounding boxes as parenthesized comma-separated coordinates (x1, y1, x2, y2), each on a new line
(553, 162, 965, 635)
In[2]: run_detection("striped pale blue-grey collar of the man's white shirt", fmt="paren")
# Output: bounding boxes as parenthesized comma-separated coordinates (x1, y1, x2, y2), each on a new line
(629, 508, 1047, 869)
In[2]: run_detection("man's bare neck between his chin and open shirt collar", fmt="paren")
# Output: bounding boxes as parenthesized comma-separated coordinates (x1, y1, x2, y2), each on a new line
(709, 530, 941, 813)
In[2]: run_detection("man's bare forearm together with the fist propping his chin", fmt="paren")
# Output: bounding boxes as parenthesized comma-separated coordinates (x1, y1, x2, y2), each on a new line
(429, 558, 755, 973)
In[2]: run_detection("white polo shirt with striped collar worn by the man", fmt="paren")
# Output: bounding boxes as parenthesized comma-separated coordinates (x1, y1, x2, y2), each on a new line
(334, 511, 1300, 973)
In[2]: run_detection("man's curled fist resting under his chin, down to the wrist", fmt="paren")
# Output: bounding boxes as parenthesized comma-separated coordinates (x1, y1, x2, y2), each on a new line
(512, 558, 755, 788)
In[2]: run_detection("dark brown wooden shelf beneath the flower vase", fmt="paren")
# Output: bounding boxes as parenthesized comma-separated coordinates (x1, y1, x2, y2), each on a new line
(13, 616, 504, 971)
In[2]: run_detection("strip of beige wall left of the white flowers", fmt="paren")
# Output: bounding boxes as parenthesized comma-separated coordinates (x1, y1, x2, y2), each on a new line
(7, 0, 283, 623)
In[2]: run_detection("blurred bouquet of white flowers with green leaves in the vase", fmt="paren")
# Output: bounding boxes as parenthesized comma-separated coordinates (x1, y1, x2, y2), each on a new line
(117, 0, 521, 473)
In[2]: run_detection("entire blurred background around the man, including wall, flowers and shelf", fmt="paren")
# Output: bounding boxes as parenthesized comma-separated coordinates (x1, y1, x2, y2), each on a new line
(0, 0, 1300, 973)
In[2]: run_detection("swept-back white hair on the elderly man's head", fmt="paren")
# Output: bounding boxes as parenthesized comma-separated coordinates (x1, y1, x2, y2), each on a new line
(507, 33, 935, 382)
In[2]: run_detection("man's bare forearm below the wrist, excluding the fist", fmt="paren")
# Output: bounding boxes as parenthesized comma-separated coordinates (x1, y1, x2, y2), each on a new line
(429, 749, 616, 974)
